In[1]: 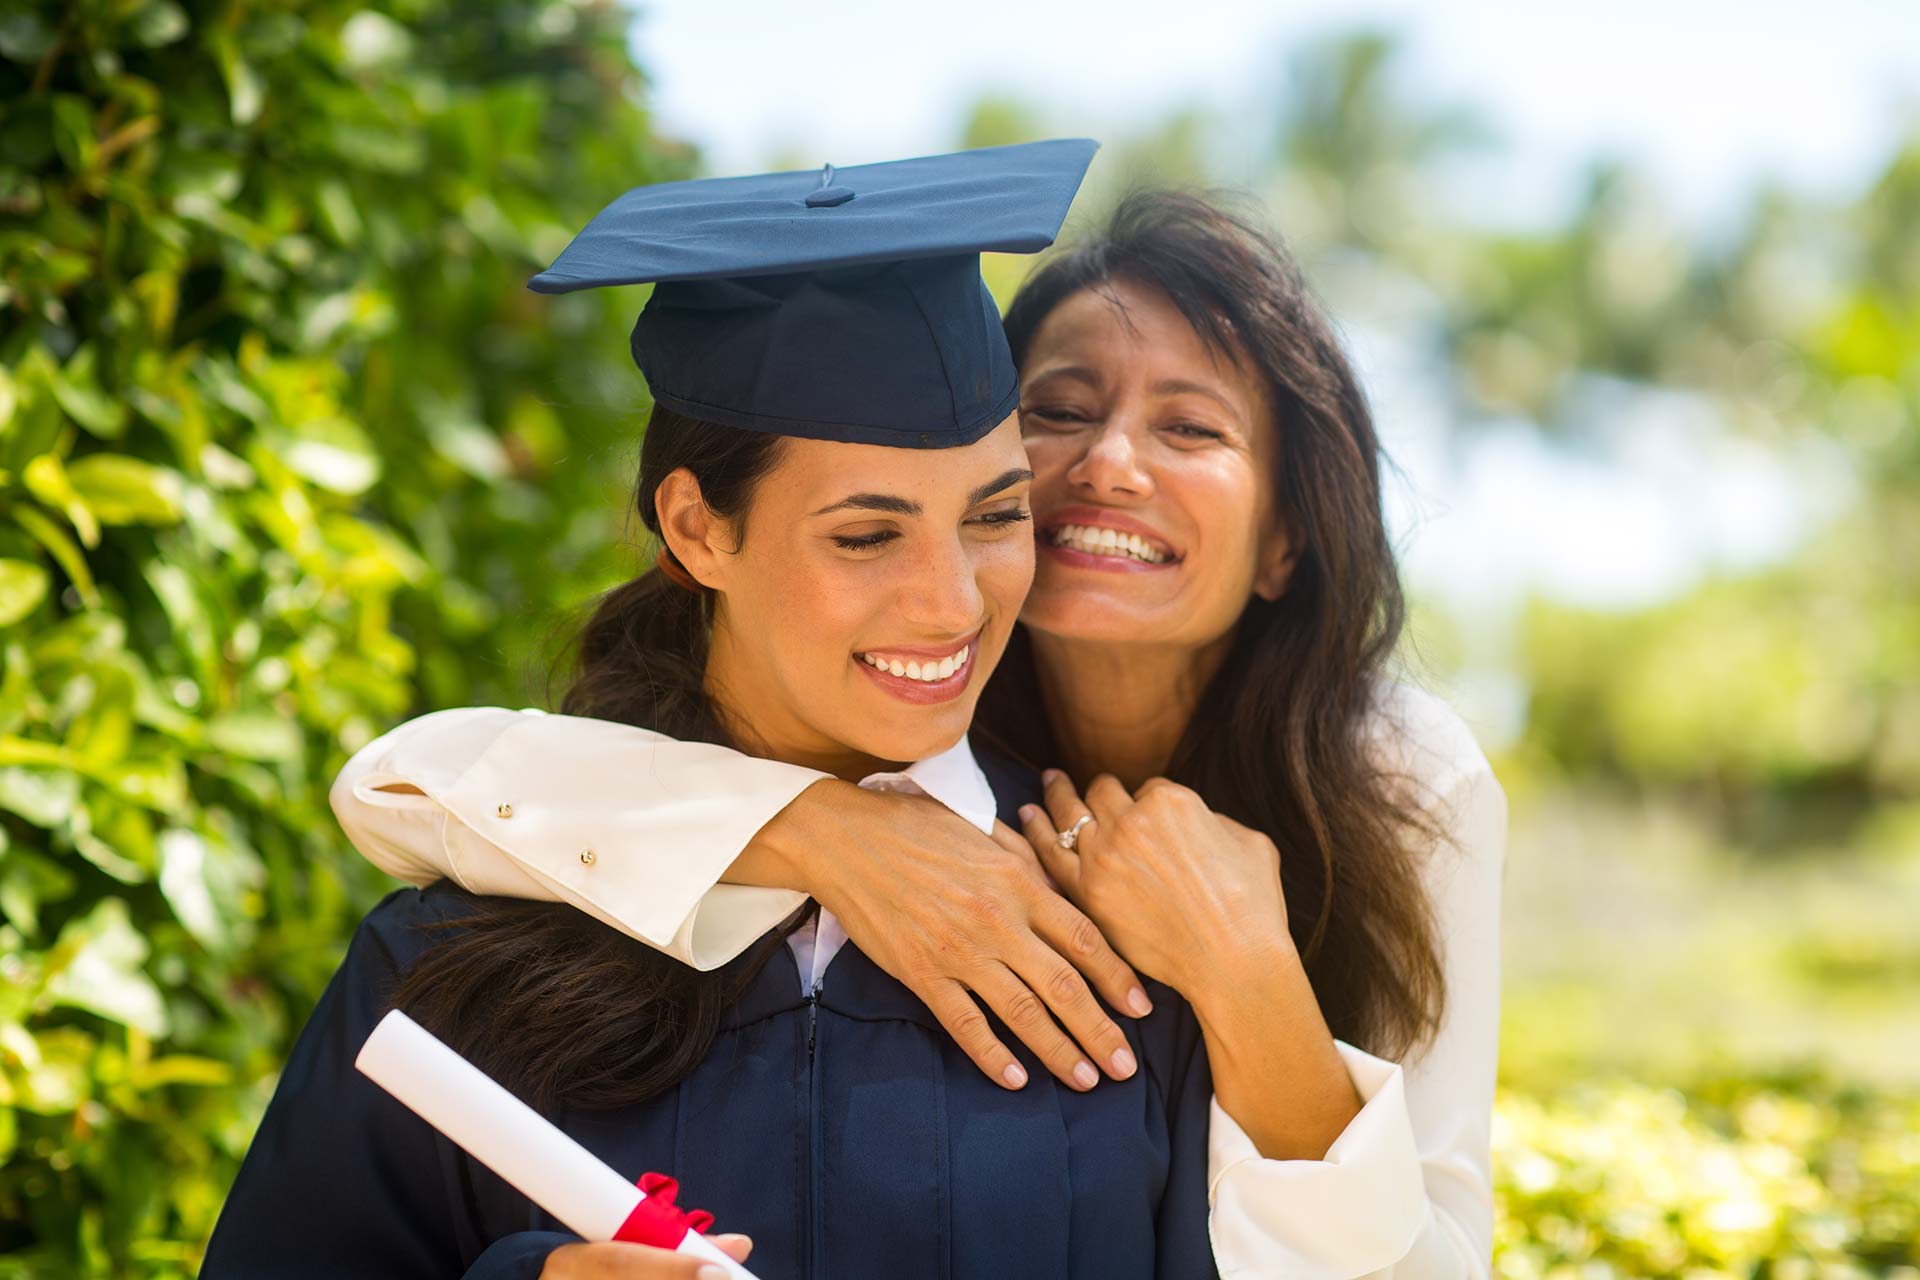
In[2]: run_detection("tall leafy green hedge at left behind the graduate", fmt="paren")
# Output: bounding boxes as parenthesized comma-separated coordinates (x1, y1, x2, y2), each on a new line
(0, 0, 689, 1276)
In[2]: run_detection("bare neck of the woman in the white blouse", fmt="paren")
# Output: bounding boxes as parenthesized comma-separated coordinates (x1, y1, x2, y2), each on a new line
(1029, 631, 1233, 791)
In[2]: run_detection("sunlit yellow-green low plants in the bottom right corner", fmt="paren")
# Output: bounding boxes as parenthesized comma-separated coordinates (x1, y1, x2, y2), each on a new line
(1494, 1071, 1920, 1280)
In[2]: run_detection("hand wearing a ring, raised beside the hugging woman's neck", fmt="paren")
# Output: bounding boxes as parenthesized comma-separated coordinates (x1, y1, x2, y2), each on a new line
(1021, 770, 1292, 1002)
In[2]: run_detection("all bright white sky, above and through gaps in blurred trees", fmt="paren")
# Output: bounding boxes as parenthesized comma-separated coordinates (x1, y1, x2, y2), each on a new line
(634, 0, 1920, 717)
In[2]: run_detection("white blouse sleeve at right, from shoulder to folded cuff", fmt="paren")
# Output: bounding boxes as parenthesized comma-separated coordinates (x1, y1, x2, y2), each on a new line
(1208, 750, 1507, 1280)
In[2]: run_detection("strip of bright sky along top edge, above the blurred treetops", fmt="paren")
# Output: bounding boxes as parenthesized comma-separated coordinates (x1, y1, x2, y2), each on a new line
(634, 0, 1920, 233)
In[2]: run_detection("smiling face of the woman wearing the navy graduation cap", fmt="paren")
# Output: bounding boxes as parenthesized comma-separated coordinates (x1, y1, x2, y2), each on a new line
(687, 418, 1033, 775)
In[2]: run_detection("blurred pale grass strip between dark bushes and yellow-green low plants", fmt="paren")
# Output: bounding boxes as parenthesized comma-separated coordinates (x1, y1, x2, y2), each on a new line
(1501, 793, 1920, 1090)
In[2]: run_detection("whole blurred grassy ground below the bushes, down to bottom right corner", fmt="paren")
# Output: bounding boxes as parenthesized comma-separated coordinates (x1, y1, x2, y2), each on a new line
(1494, 787, 1920, 1280)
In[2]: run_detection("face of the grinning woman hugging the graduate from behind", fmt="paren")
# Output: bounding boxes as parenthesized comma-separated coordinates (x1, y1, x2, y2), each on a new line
(1020, 280, 1292, 649)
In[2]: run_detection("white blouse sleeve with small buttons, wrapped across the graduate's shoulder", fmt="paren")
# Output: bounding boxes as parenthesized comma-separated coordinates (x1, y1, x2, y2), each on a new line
(328, 706, 826, 969)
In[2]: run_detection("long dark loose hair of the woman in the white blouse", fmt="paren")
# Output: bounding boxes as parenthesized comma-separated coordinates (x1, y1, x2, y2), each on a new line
(979, 190, 1446, 1057)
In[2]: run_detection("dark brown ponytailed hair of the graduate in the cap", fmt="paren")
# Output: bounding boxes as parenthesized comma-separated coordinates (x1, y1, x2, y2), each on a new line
(394, 407, 804, 1107)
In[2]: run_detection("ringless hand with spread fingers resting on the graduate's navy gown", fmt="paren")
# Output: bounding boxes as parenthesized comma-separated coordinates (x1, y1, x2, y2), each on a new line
(728, 781, 1152, 1090)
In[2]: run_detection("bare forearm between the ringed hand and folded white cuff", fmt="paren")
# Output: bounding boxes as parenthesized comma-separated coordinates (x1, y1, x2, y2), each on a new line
(1188, 942, 1363, 1161)
